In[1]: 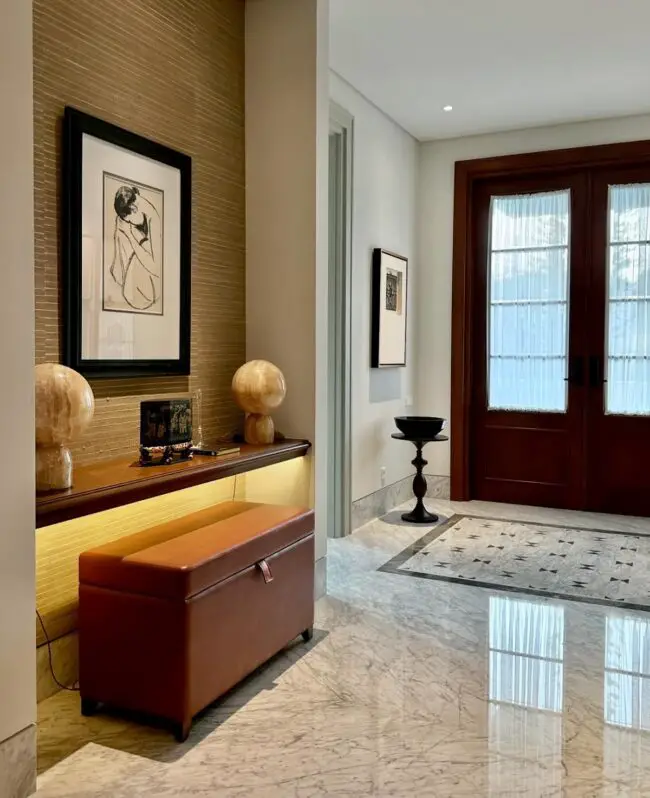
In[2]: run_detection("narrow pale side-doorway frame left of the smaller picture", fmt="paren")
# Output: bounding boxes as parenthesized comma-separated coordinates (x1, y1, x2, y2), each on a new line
(327, 101, 354, 537)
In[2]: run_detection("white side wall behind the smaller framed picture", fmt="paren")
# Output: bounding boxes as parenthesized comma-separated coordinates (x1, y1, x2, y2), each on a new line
(330, 72, 420, 500)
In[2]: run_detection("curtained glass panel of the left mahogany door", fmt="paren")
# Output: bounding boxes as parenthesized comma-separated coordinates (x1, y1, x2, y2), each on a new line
(488, 190, 570, 412)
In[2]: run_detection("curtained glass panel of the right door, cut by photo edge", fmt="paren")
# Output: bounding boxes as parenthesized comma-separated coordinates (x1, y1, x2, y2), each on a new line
(605, 183, 650, 415)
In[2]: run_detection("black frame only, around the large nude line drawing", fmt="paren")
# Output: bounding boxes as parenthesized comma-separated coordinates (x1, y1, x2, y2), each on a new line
(61, 106, 192, 379)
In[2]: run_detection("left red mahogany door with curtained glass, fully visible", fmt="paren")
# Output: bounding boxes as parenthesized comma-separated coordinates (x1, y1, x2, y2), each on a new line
(471, 173, 589, 508)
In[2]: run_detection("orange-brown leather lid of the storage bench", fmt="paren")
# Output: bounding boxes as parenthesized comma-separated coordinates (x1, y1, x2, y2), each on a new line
(79, 502, 314, 599)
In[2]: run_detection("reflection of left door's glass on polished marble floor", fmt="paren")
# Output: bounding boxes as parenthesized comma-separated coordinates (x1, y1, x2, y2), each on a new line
(489, 596, 564, 795)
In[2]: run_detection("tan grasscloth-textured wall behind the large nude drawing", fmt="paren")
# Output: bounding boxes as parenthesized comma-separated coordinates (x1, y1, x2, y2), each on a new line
(34, 0, 245, 463)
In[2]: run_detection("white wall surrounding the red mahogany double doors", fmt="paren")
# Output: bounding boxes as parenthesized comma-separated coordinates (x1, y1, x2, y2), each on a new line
(417, 111, 650, 475)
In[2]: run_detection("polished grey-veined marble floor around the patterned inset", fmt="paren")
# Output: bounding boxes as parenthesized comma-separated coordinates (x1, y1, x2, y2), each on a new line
(38, 500, 650, 798)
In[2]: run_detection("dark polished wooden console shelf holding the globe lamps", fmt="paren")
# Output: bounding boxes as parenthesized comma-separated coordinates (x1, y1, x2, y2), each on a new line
(36, 440, 311, 528)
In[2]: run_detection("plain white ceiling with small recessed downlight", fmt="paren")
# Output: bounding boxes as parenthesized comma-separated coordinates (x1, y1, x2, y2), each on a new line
(330, 0, 650, 140)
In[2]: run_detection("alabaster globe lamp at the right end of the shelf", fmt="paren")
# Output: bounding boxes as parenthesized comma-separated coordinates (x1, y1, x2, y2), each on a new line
(232, 360, 287, 444)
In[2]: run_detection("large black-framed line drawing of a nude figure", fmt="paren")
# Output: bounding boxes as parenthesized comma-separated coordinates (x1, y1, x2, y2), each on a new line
(63, 107, 192, 377)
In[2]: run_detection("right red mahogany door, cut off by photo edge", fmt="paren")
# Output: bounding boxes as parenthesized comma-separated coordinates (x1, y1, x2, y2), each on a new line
(586, 166, 650, 515)
